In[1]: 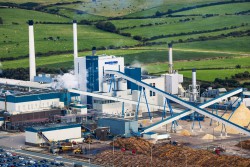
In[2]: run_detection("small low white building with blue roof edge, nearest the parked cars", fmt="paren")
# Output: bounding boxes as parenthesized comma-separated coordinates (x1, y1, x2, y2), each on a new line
(25, 124, 81, 145)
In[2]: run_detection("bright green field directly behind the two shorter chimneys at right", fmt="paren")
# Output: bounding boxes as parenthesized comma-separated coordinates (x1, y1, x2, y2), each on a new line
(143, 57, 250, 81)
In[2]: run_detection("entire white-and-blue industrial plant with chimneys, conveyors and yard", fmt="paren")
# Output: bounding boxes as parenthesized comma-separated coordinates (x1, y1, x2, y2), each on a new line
(0, 20, 250, 166)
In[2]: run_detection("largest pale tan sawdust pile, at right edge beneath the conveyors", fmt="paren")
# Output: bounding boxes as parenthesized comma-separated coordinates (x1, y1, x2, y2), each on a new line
(214, 103, 250, 134)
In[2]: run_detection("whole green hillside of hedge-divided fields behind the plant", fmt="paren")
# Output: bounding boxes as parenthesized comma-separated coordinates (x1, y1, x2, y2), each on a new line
(0, 0, 250, 81)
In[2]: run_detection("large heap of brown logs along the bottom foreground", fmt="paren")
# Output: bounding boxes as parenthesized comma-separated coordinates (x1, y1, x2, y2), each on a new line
(94, 138, 250, 167)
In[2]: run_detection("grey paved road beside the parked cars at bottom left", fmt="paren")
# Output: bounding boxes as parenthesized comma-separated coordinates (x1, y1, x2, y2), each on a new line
(3, 147, 101, 167)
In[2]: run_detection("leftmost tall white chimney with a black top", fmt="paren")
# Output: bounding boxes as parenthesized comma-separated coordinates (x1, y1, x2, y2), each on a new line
(29, 20, 36, 81)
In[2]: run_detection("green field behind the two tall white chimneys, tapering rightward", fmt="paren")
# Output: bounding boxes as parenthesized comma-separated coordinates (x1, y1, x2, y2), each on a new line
(0, 24, 138, 57)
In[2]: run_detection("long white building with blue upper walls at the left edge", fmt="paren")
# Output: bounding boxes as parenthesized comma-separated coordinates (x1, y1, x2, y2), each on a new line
(0, 90, 78, 115)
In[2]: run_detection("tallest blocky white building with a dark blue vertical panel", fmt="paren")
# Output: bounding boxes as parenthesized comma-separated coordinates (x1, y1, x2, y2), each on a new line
(74, 51, 127, 104)
